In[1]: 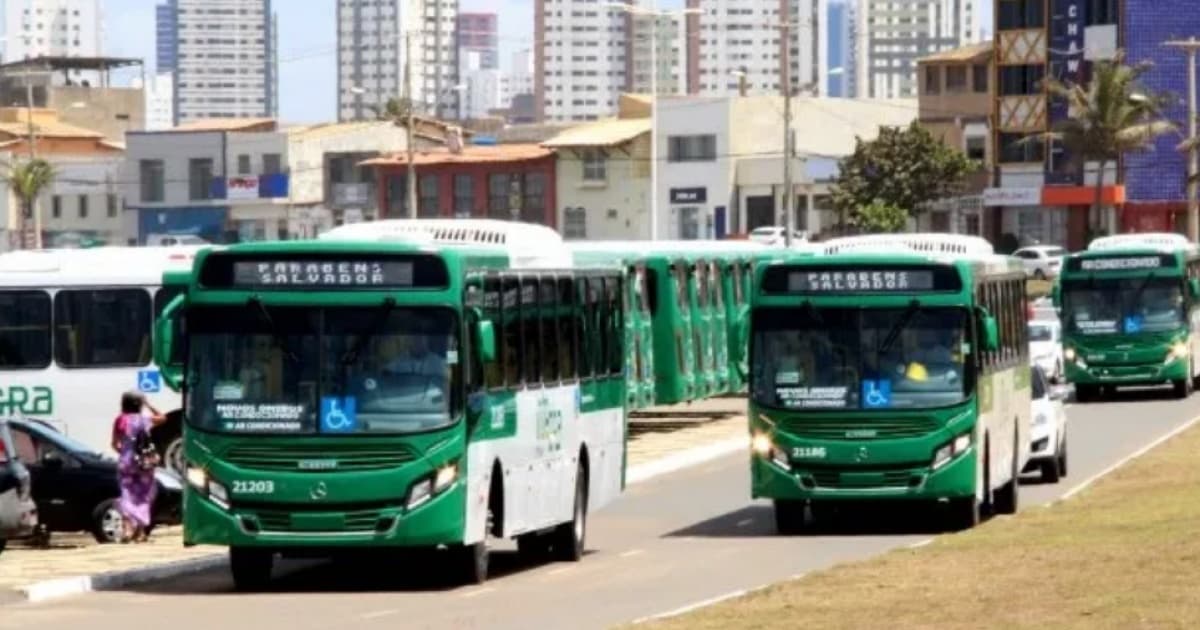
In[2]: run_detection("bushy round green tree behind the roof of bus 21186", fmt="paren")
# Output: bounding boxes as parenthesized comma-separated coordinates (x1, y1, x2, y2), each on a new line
(833, 121, 979, 216)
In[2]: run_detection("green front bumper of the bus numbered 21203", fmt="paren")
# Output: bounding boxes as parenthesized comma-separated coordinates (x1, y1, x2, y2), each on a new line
(184, 482, 466, 550)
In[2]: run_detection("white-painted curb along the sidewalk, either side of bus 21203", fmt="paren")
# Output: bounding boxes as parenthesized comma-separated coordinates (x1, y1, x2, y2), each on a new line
(16, 437, 746, 604)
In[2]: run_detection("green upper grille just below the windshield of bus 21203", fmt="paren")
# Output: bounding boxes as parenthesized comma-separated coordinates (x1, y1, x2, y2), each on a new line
(224, 444, 416, 473)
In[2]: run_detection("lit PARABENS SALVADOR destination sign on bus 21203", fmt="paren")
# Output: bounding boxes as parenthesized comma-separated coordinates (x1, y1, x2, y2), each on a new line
(233, 260, 413, 288)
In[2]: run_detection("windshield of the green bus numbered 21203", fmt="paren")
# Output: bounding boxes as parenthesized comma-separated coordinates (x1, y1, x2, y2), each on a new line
(186, 302, 461, 434)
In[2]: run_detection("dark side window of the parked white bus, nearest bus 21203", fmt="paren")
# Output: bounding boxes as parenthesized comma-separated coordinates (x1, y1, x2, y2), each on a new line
(54, 289, 151, 367)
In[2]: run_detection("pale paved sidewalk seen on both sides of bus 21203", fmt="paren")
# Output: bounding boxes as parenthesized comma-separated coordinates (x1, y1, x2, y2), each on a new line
(0, 400, 746, 604)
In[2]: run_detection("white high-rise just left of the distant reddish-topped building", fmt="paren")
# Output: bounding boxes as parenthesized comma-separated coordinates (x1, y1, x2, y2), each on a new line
(337, 0, 463, 120)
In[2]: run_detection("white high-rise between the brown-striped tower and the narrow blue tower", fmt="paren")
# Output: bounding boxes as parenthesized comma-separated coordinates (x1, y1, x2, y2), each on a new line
(688, 0, 829, 96)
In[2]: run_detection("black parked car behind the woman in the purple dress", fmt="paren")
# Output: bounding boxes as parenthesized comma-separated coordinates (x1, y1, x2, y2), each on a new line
(8, 420, 182, 542)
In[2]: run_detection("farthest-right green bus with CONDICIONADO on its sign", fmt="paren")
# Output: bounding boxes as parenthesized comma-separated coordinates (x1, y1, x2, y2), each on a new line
(1054, 234, 1200, 402)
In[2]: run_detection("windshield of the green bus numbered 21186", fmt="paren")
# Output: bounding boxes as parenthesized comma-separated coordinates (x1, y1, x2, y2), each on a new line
(751, 305, 973, 410)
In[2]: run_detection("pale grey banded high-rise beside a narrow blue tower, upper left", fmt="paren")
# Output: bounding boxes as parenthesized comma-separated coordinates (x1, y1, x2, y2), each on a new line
(173, 0, 278, 125)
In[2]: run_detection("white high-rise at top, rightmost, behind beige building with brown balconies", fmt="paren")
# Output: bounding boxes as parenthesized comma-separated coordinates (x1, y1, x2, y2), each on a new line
(853, 0, 979, 98)
